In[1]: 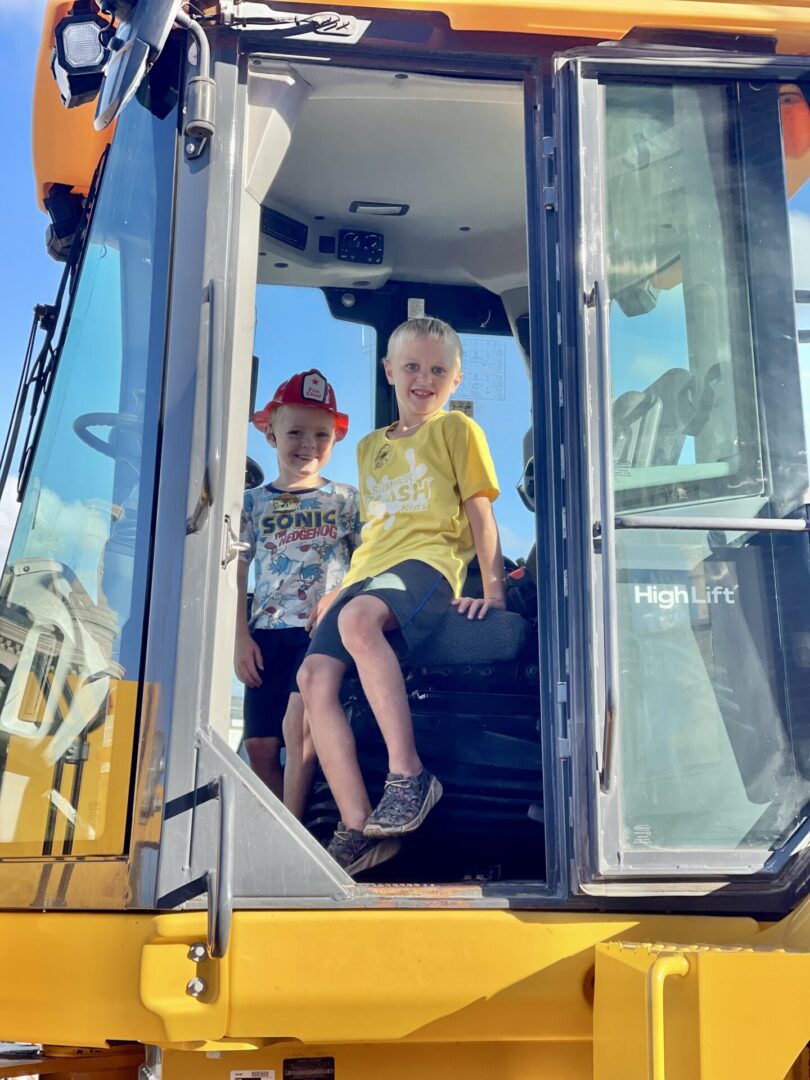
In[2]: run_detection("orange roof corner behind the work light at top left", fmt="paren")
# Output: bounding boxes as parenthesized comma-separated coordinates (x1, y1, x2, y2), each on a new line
(33, 0, 113, 210)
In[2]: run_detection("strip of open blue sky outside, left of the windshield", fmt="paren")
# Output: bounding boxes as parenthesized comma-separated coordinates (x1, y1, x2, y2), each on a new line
(0, 0, 62, 550)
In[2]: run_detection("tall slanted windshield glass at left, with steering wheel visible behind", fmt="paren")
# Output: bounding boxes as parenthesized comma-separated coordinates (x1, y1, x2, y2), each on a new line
(0, 90, 175, 856)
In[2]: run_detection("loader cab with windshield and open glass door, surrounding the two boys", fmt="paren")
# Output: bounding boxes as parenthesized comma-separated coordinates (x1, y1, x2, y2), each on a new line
(0, 4, 810, 924)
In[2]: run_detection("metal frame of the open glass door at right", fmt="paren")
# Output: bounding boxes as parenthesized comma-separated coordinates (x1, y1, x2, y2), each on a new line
(555, 45, 810, 910)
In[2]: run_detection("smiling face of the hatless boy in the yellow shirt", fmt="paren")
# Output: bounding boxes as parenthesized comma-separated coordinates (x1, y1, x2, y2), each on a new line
(383, 338, 461, 420)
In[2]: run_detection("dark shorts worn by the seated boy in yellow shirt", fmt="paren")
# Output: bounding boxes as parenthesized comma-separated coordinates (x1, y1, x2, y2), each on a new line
(309, 558, 453, 667)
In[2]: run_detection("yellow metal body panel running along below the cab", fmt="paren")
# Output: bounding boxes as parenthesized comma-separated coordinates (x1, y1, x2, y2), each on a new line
(0, 901, 810, 1080)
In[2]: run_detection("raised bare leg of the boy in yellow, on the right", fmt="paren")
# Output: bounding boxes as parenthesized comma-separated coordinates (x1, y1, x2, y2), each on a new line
(338, 596, 422, 777)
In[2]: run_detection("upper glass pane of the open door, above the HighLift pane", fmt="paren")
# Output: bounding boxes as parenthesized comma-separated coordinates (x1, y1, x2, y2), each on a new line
(606, 84, 765, 510)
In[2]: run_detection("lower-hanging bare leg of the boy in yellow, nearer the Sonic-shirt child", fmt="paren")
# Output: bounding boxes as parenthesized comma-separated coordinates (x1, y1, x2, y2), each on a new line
(298, 652, 372, 829)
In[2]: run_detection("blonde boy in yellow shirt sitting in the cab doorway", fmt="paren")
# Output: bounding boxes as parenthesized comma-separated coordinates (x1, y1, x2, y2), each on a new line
(298, 319, 505, 874)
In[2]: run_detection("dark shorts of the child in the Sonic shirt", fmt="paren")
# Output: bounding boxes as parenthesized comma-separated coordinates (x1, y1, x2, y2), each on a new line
(244, 629, 310, 739)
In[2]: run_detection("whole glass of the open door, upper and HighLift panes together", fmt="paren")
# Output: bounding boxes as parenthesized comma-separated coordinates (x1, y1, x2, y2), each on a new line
(606, 83, 810, 852)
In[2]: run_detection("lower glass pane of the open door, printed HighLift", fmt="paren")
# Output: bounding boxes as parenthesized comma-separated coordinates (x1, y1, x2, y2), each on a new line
(617, 529, 810, 849)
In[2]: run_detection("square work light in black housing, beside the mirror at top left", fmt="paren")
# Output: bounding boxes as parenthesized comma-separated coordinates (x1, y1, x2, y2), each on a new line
(51, 3, 113, 109)
